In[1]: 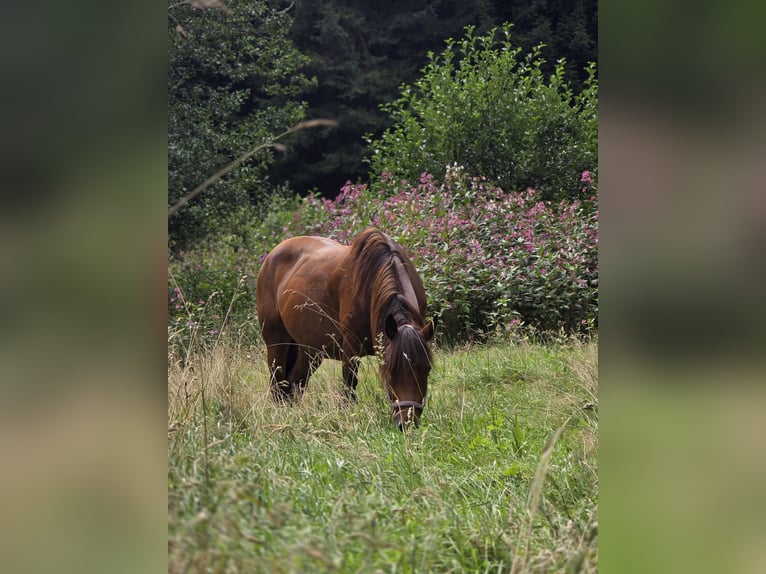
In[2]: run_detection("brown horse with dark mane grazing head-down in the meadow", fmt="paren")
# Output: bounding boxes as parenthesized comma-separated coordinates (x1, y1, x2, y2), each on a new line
(256, 228, 434, 429)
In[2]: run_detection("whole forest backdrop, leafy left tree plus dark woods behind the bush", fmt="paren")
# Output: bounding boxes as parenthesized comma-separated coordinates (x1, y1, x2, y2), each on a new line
(168, 0, 598, 251)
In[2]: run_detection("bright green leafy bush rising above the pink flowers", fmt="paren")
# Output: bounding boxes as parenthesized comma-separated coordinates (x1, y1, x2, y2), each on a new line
(368, 24, 598, 205)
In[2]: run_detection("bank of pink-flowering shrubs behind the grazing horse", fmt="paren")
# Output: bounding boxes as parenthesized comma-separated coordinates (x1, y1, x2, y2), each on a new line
(170, 166, 598, 346)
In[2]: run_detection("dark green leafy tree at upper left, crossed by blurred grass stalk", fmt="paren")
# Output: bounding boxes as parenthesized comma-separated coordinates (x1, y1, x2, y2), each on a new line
(168, 0, 311, 246)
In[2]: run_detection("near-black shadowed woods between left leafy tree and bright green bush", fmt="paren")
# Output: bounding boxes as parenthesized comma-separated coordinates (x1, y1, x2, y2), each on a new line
(270, 0, 598, 197)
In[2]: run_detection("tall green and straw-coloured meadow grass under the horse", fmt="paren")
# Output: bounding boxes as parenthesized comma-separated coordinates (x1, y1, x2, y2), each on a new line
(168, 316, 598, 572)
